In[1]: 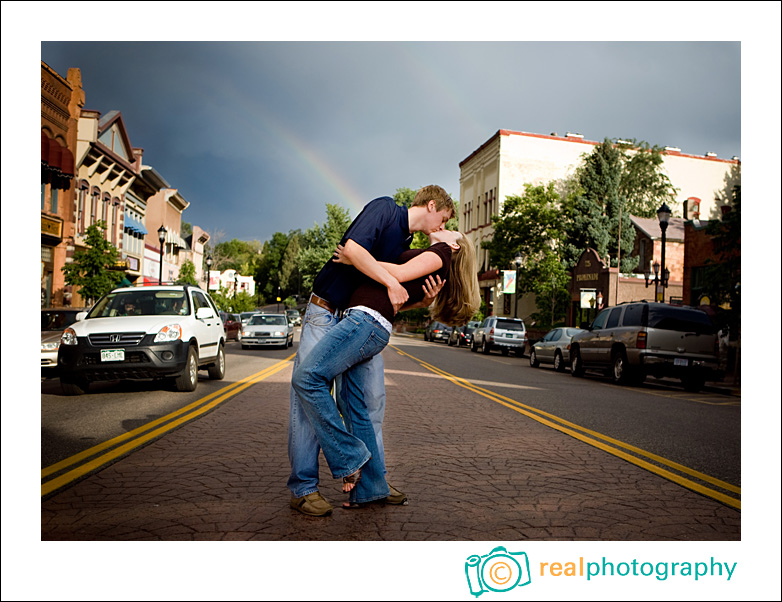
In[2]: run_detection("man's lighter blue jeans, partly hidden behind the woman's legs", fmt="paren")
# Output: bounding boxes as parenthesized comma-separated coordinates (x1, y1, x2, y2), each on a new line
(288, 303, 385, 497)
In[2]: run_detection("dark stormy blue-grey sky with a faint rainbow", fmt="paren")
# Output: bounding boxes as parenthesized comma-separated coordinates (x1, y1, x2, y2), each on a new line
(35, 34, 741, 242)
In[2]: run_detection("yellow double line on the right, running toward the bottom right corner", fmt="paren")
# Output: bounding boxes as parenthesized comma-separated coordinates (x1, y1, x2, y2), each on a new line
(396, 345, 741, 510)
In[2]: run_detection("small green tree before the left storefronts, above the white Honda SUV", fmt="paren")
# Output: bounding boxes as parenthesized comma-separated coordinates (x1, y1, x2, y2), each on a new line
(62, 220, 123, 305)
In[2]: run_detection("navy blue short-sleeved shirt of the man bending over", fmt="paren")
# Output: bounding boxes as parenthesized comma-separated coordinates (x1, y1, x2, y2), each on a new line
(312, 196, 413, 309)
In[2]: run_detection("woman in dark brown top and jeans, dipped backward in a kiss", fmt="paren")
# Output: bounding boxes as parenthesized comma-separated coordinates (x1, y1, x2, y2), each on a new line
(292, 230, 480, 508)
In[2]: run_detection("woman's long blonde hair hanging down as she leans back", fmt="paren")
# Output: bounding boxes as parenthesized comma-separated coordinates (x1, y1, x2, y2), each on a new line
(430, 233, 481, 326)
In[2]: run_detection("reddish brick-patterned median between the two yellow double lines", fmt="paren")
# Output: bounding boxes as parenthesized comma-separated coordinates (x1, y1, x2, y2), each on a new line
(41, 339, 741, 541)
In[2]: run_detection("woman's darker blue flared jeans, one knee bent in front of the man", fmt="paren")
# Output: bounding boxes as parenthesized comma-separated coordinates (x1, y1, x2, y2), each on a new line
(291, 310, 389, 503)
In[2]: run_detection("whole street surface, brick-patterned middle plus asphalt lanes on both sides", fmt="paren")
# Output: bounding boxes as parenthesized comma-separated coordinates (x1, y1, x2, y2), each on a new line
(42, 333, 740, 540)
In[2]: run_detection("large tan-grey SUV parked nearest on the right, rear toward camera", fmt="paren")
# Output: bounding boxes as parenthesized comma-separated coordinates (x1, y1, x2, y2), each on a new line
(570, 301, 722, 391)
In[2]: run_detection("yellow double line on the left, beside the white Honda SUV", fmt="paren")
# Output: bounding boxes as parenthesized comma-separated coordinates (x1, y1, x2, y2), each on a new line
(41, 355, 294, 496)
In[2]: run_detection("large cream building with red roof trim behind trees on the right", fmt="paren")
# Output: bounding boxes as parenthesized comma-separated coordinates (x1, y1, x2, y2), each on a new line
(459, 130, 741, 319)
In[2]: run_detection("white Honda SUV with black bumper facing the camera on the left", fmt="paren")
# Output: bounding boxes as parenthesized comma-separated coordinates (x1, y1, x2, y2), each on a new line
(58, 285, 225, 395)
